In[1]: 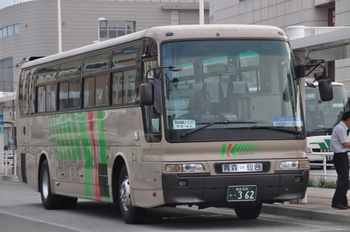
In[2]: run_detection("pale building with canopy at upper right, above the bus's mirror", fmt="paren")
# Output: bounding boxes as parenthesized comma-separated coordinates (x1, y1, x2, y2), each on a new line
(209, 0, 350, 90)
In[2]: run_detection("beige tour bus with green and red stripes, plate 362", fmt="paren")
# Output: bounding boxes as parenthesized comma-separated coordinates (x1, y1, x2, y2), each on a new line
(17, 25, 328, 224)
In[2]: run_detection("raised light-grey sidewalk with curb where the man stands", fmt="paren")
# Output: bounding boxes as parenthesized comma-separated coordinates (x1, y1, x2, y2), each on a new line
(0, 174, 350, 224)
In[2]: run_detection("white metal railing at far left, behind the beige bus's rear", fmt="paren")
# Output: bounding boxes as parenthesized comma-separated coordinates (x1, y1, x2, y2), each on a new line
(0, 150, 17, 176)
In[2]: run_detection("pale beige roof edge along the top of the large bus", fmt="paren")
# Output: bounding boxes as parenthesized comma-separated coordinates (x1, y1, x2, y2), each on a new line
(21, 24, 288, 68)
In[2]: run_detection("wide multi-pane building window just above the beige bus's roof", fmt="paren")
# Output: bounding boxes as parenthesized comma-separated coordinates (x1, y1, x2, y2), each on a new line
(100, 21, 136, 38)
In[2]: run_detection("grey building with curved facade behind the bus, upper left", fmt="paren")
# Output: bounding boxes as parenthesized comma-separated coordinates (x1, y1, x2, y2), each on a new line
(0, 0, 209, 149)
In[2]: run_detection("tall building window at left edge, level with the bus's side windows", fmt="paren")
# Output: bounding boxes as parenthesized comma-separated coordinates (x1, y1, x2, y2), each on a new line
(0, 58, 13, 92)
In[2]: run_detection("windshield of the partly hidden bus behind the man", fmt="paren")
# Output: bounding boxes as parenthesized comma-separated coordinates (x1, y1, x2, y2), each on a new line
(305, 84, 349, 136)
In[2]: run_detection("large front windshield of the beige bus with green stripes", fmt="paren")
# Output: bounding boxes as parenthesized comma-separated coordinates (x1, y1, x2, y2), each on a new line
(162, 40, 303, 141)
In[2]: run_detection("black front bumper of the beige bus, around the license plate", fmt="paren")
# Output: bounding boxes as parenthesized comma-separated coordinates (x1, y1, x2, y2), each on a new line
(162, 170, 309, 208)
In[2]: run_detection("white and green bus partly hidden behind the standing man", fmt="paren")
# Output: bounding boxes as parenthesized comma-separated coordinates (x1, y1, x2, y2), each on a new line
(305, 82, 350, 168)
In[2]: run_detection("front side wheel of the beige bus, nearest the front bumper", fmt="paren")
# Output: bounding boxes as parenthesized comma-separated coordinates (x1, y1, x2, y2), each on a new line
(118, 165, 147, 224)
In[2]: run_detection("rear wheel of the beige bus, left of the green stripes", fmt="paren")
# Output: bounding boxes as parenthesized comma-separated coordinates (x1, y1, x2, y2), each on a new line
(40, 160, 62, 209)
